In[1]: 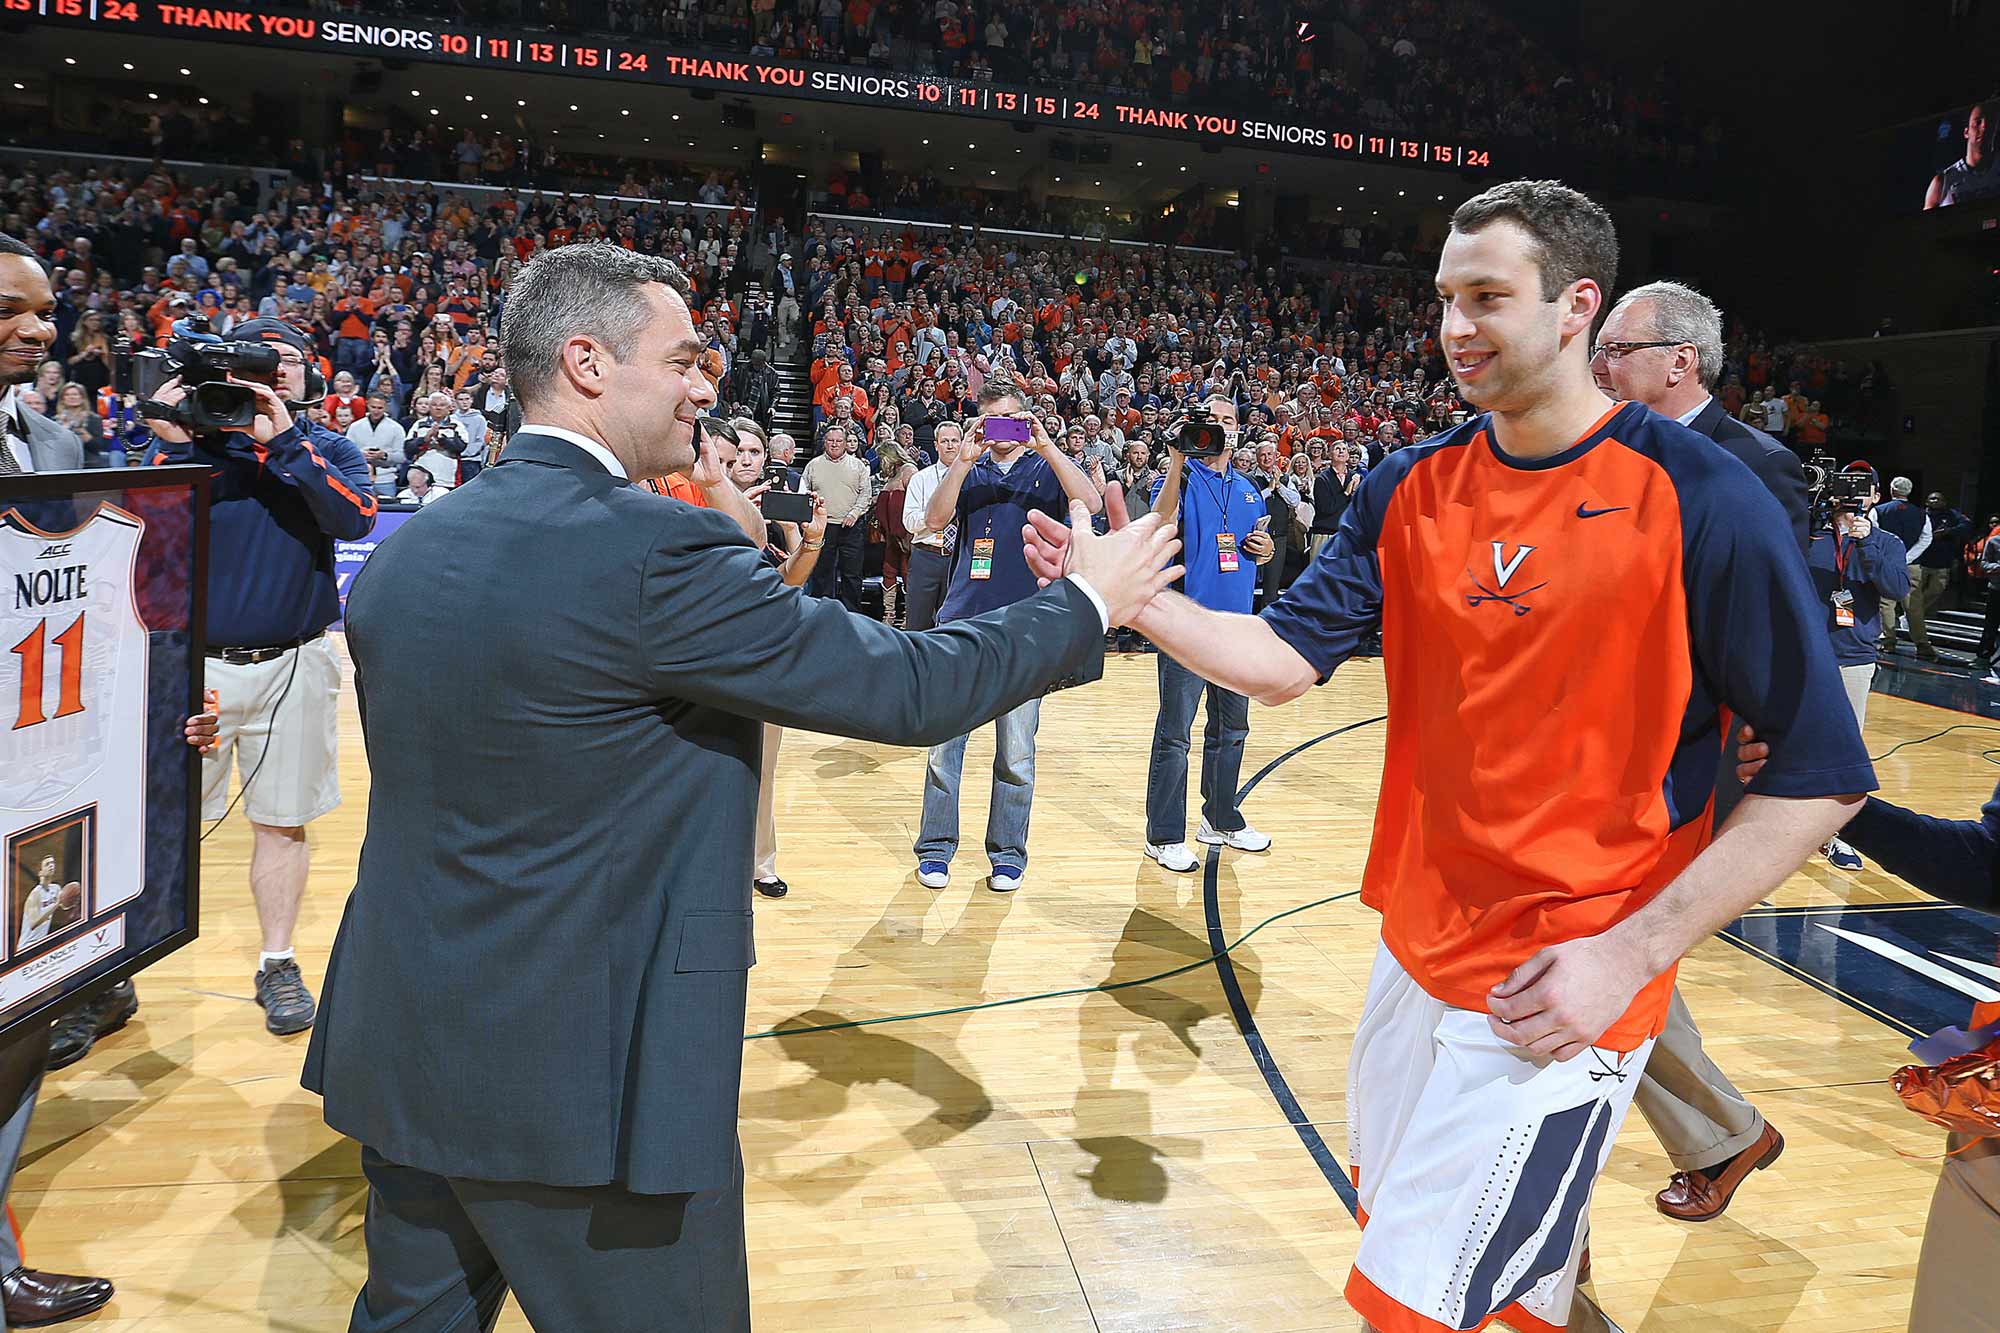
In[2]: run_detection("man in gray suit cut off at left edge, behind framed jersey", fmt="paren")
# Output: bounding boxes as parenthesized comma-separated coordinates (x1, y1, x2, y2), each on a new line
(0, 234, 112, 1327)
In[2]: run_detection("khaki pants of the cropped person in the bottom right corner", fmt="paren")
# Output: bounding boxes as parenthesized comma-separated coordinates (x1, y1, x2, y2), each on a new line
(1910, 1135, 2000, 1333)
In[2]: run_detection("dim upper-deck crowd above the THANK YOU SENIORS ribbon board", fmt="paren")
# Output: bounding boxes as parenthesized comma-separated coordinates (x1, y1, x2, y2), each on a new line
(312, 0, 1724, 162)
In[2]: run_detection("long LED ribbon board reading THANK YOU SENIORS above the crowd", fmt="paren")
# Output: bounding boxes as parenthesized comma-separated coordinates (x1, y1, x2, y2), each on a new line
(23, 0, 1492, 170)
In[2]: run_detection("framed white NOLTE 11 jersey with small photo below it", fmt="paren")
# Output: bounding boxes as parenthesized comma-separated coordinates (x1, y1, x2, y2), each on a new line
(0, 466, 208, 1033)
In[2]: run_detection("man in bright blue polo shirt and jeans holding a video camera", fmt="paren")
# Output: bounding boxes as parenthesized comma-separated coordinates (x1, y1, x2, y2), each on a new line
(1146, 394, 1276, 871)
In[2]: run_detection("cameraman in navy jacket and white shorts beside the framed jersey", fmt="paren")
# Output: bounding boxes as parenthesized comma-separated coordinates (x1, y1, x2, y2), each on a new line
(142, 318, 376, 1035)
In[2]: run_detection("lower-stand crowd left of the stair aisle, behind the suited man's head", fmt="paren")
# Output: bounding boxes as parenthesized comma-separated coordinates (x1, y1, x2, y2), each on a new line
(0, 164, 772, 494)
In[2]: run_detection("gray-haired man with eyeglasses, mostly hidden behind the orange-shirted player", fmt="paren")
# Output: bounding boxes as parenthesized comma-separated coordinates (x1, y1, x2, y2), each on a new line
(1590, 282, 1808, 1221)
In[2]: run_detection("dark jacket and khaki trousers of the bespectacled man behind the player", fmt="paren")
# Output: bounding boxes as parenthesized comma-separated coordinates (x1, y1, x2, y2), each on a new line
(1632, 398, 1812, 1171)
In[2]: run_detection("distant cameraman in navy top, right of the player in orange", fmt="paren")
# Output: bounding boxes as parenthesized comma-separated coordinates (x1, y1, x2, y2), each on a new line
(1806, 470, 1910, 871)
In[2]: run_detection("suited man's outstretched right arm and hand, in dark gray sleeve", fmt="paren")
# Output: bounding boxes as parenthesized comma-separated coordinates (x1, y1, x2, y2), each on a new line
(638, 500, 1180, 745)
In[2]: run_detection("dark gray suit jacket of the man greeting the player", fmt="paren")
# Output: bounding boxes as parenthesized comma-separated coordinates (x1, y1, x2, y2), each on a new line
(304, 432, 1104, 1193)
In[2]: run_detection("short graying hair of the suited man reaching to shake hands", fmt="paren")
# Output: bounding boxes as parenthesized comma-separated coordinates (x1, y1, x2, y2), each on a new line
(500, 240, 692, 406)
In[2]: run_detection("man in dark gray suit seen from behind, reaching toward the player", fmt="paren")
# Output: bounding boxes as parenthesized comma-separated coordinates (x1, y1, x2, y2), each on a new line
(304, 244, 1178, 1333)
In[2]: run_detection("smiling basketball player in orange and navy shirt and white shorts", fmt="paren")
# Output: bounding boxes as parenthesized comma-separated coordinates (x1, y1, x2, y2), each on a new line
(1030, 180, 1874, 1333)
